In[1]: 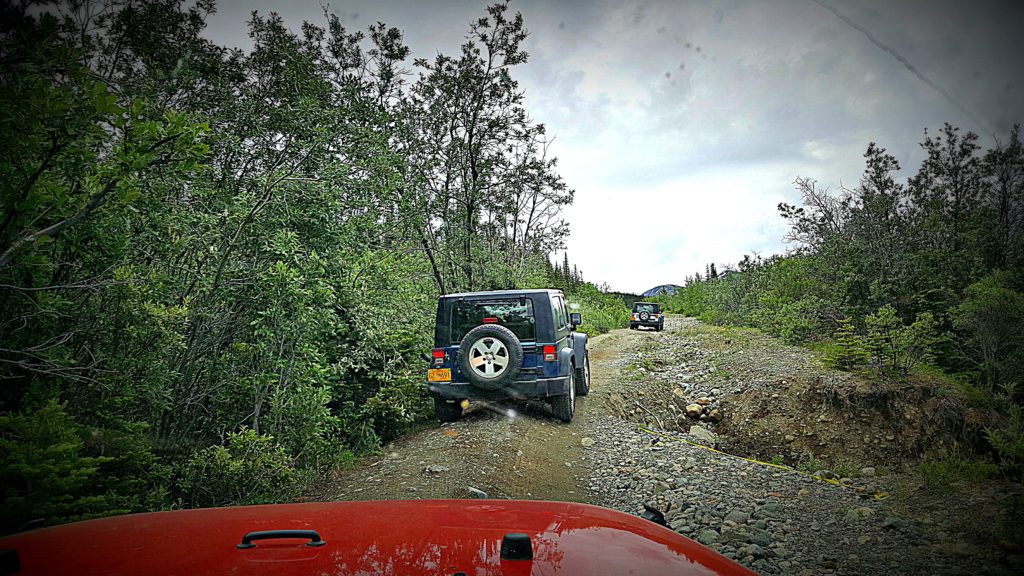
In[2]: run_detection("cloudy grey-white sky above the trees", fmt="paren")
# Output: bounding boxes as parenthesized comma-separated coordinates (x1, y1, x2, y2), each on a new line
(209, 0, 1024, 292)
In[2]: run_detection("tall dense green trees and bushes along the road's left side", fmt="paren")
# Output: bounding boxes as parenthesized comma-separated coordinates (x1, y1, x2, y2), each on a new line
(0, 0, 625, 530)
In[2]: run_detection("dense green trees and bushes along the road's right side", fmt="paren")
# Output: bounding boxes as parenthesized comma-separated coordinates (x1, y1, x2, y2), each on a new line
(662, 125, 1024, 473)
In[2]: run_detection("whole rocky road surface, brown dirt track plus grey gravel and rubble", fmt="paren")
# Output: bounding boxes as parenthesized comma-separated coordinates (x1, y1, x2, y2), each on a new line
(311, 317, 1024, 576)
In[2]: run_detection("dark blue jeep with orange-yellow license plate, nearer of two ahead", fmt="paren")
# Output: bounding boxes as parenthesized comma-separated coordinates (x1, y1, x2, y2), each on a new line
(427, 290, 590, 422)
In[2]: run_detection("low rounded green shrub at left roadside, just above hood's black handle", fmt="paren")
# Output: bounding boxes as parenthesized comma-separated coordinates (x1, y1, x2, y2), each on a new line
(178, 428, 297, 507)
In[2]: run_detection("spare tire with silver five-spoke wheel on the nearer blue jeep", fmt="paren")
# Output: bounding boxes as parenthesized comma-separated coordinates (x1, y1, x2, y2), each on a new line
(459, 324, 522, 390)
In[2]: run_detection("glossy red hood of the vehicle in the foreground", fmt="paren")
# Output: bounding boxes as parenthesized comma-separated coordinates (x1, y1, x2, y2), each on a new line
(0, 500, 753, 576)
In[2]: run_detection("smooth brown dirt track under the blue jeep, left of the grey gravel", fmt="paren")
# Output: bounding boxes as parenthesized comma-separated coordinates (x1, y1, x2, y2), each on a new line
(310, 330, 643, 502)
